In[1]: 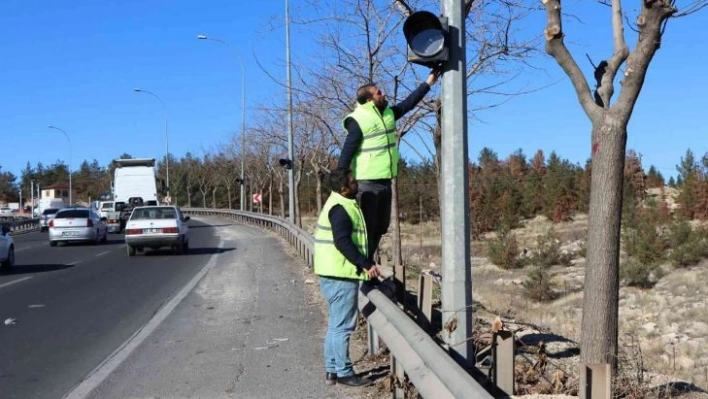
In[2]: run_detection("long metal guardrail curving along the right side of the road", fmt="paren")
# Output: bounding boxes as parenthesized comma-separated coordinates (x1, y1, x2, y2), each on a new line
(182, 208, 494, 399)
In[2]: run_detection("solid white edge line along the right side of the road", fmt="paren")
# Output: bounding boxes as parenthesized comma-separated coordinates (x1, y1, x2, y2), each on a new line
(63, 239, 224, 399)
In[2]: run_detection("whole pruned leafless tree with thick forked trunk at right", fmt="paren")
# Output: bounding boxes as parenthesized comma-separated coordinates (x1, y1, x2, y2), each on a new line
(542, 0, 705, 369)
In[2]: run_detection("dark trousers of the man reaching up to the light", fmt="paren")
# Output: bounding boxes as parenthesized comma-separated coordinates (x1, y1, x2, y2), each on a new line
(356, 179, 391, 262)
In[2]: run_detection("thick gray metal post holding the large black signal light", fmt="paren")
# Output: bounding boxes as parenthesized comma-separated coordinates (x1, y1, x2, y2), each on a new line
(441, 0, 474, 368)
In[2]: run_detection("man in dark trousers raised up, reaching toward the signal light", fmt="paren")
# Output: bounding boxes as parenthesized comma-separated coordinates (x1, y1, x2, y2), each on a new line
(337, 68, 440, 260)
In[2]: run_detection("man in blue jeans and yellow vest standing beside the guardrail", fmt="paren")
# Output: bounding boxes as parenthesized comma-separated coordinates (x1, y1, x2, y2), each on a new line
(314, 169, 380, 387)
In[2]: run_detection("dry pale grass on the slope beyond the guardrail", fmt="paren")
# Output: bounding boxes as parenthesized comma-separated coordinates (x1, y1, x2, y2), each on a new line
(303, 215, 708, 398)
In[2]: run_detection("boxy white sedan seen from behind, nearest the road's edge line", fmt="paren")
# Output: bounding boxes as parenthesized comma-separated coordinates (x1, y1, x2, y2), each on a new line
(125, 205, 189, 256)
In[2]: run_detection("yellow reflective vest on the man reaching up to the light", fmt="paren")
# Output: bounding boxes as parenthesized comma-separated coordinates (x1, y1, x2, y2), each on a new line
(342, 101, 398, 180)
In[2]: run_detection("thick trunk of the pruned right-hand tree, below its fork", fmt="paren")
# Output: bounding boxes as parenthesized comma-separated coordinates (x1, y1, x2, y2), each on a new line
(580, 111, 627, 370)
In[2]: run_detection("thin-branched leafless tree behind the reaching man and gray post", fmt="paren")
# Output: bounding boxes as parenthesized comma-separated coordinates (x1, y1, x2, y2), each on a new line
(290, 0, 542, 263)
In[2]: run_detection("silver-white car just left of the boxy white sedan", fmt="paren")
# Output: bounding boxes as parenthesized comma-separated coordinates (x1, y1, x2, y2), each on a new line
(49, 207, 108, 247)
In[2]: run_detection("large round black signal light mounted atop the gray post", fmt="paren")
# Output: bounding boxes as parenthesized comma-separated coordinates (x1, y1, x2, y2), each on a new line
(403, 11, 450, 68)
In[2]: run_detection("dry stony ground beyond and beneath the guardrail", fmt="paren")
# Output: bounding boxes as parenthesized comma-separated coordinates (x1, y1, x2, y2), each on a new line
(296, 215, 708, 399)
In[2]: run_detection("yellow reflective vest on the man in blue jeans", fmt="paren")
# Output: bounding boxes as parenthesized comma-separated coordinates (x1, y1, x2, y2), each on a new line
(314, 192, 369, 280)
